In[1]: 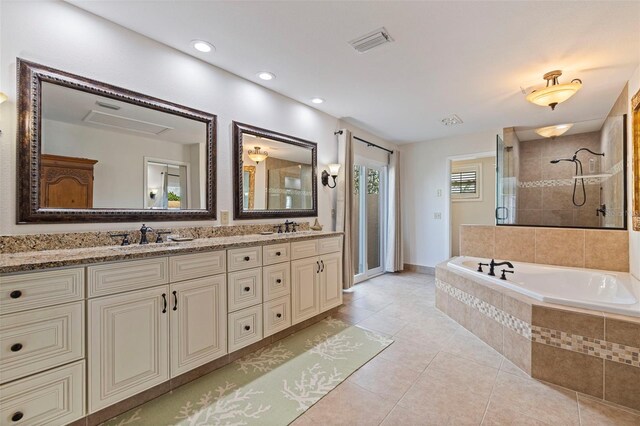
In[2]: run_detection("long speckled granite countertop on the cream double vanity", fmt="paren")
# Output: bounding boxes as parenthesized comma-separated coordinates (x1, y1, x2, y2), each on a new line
(0, 231, 342, 274)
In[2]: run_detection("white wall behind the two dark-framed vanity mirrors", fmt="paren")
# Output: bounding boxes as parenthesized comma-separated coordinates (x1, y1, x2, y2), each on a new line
(0, 1, 398, 235)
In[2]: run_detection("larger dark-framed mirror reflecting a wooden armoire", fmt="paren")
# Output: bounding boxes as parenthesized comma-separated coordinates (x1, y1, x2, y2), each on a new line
(18, 60, 216, 222)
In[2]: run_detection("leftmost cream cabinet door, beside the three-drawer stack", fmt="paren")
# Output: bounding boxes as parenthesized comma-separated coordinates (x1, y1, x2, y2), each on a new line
(88, 285, 170, 413)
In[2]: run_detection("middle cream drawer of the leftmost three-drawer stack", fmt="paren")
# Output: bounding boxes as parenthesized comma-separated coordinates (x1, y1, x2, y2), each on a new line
(0, 302, 84, 383)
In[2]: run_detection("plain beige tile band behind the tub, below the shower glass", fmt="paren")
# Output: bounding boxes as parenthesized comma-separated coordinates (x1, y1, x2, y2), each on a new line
(460, 225, 629, 272)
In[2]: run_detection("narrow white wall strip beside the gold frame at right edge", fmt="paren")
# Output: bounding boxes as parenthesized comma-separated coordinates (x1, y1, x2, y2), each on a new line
(627, 66, 640, 279)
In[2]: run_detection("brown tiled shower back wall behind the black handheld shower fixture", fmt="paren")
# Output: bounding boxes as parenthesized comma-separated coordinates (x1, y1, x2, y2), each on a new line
(517, 132, 604, 227)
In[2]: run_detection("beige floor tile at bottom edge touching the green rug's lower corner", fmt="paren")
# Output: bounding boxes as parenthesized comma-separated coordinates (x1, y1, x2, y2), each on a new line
(292, 381, 394, 426)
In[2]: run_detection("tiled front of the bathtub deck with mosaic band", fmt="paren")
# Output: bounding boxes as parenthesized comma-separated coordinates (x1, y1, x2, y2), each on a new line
(436, 263, 640, 410)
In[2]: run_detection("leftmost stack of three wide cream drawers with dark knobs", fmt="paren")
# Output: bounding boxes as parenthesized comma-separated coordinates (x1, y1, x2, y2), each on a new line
(0, 268, 86, 425)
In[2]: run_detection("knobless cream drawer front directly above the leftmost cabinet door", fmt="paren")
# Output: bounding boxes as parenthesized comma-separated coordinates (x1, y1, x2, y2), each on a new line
(87, 257, 169, 297)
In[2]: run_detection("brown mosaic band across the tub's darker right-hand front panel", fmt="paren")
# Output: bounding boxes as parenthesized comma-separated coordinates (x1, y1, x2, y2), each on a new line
(531, 325, 640, 367)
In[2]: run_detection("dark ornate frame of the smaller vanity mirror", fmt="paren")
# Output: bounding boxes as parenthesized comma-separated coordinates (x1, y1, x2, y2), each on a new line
(233, 121, 318, 219)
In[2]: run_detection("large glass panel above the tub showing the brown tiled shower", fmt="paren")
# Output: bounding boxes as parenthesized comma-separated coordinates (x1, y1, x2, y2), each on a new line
(496, 111, 627, 229)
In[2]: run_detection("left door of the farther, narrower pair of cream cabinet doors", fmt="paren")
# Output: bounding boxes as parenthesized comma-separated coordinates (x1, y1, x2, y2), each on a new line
(291, 257, 320, 324)
